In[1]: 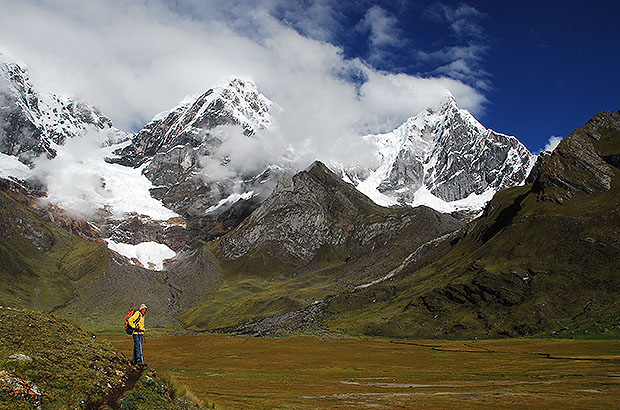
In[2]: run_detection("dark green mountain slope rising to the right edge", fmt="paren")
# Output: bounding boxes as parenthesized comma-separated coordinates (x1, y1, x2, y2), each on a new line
(329, 112, 620, 338)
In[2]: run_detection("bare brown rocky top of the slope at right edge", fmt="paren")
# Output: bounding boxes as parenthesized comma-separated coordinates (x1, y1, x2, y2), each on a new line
(535, 111, 620, 202)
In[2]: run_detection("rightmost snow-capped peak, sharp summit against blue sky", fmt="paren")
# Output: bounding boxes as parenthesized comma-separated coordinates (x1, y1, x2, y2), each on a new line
(341, 95, 536, 212)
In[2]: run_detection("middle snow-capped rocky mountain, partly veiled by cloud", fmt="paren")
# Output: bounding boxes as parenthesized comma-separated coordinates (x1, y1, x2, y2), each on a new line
(111, 79, 278, 216)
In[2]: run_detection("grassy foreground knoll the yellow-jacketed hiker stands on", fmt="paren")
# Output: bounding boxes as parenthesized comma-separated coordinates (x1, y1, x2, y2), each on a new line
(0, 307, 197, 410)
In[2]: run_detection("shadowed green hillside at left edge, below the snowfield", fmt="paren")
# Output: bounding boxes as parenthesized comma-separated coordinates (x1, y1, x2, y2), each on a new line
(0, 191, 108, 311)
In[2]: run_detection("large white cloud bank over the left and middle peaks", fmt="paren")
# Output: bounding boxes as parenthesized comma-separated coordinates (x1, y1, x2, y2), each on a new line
(0, 0, 485, 172)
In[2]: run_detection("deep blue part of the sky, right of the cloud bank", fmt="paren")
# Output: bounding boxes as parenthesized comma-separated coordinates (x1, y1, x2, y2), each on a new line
(268, 0, 620, 151)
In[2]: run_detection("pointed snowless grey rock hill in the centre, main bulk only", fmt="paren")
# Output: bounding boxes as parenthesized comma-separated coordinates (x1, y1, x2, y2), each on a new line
(221, 162, 379, 264)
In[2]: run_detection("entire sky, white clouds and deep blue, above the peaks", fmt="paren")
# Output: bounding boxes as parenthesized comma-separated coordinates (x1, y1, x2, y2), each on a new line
(0, 0, 620, 154)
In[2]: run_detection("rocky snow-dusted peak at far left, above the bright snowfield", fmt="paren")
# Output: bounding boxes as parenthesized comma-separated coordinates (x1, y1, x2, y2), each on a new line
(0, 54, 129, 163)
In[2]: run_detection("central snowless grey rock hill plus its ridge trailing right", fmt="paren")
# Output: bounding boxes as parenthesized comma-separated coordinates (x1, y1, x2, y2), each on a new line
(220, 162, 460, 265)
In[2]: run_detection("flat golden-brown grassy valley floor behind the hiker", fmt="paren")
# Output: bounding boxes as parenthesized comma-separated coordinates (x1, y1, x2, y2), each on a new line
(106, 335, 620, 409)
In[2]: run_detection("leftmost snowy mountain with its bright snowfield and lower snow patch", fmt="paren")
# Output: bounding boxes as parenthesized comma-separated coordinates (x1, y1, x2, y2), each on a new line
(0, 54, 183, 269)
